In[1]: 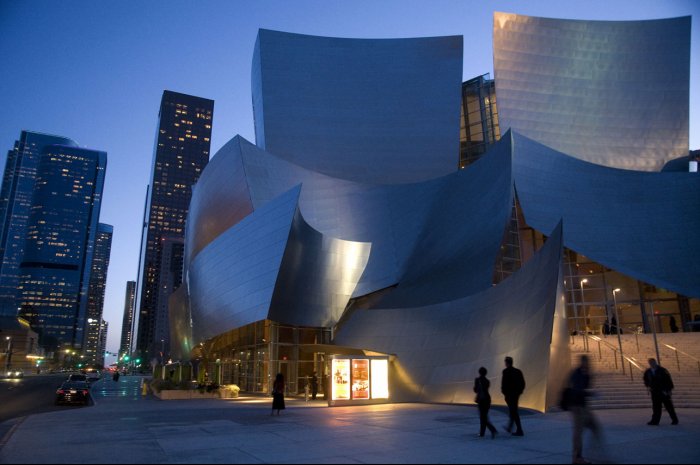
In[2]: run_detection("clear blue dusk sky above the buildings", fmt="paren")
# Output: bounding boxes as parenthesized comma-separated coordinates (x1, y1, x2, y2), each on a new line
(0, 0, 700, 352)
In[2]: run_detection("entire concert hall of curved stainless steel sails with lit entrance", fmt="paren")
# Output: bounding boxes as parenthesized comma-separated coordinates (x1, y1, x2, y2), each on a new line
(169, 13, 700, 411)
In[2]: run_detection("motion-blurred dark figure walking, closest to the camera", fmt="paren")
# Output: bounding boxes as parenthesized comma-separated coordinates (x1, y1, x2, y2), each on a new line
(567, 355, 602, 464)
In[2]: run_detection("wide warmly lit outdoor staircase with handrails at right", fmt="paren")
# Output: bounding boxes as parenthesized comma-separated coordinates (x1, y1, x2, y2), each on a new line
(571, 333, 700, 409)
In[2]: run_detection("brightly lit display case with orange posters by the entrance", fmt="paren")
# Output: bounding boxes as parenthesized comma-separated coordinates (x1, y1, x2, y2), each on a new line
(328, 355, 390, 406)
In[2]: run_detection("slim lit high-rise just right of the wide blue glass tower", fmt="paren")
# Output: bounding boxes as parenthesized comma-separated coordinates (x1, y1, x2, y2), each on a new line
(83, 223, 114, 365)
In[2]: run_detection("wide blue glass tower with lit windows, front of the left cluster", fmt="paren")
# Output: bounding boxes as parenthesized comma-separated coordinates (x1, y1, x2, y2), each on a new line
(17, 145, 107, 349)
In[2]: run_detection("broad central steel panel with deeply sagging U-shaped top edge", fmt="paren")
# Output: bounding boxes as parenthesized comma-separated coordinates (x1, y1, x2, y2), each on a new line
(240, 136, 512, 305)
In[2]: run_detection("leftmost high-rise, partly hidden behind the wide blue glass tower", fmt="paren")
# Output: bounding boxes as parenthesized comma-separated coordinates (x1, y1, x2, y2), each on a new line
(0, 131, 78, 317)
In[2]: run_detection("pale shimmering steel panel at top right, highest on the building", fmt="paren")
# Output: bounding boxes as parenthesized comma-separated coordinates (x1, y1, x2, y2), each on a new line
(493, 13, 690, 171)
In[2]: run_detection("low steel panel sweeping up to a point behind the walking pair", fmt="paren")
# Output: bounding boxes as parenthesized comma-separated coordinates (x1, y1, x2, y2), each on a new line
(334, 226, 570, 411)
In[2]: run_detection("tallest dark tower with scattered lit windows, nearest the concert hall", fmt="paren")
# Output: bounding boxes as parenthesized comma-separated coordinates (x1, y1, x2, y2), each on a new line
(136, 90, 214, 361)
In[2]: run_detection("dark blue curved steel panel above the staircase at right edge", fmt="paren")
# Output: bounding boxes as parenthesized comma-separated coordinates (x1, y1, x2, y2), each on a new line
(513, 130, 700, 297)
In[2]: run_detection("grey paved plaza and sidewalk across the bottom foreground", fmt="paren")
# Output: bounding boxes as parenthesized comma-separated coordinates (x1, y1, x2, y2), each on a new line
(0, 377, 700, 463)
